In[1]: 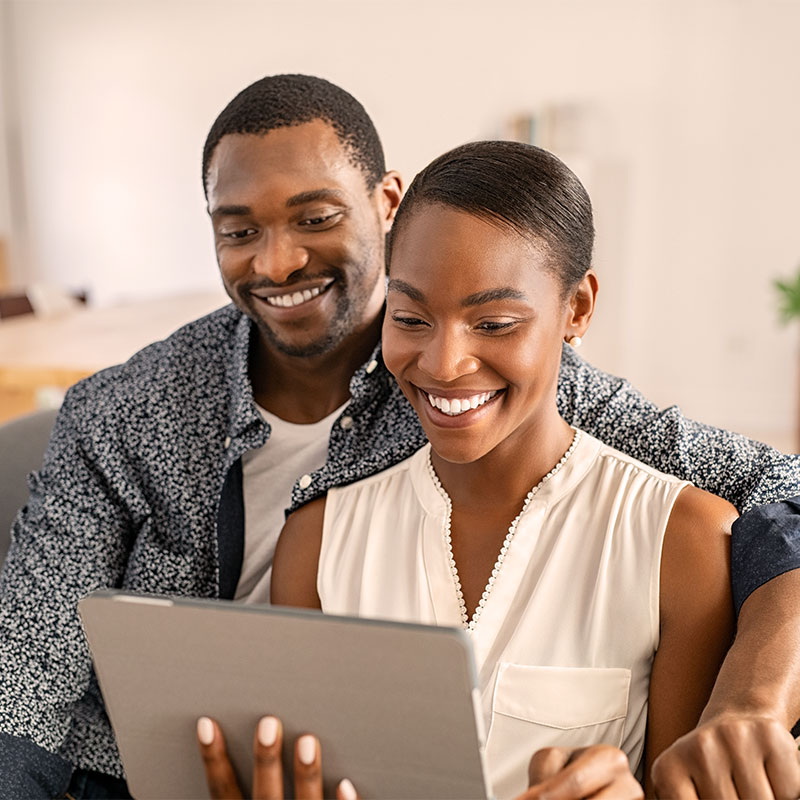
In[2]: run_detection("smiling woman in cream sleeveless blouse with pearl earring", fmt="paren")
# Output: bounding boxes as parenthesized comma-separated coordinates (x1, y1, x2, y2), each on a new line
(272, 142, 736, 798)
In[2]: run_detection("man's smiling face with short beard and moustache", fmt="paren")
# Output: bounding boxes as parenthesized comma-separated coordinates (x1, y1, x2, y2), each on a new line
(207, 120, 399, 356)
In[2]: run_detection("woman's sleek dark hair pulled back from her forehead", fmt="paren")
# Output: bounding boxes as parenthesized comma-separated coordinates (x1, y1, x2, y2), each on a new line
(386, 141, 594, 294)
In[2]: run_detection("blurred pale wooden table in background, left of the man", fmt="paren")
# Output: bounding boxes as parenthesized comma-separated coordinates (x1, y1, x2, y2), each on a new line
(0, 289, 227, 423)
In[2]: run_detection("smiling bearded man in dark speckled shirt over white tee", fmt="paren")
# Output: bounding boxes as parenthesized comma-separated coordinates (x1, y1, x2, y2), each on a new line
(0, 75, 800, 797)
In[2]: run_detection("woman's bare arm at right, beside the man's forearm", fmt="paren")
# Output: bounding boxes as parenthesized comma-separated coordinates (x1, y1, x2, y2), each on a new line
(645, 487, 737, 796)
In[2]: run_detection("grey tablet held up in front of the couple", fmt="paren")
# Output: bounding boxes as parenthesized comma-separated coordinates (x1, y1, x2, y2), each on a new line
(78, 591, 489, 800)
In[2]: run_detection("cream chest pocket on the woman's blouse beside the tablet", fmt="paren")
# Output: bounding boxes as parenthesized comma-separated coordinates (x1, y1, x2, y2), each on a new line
(486, 662, 631, 798)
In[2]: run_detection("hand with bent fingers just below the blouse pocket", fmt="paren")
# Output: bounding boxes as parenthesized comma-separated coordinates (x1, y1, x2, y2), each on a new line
(518, 744, 644, 800)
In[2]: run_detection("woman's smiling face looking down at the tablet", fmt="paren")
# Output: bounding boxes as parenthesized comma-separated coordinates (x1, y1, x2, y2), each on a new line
(383, 204, 575, 463)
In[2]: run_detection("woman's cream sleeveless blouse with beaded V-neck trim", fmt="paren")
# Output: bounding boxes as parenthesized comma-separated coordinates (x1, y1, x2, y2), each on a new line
(317, 433, 687, 798)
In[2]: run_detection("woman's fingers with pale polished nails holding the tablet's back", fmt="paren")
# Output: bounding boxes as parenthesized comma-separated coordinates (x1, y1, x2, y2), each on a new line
(197, 717, 358, 800)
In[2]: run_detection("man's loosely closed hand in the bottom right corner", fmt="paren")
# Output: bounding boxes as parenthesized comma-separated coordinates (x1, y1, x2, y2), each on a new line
(651, 714, 800, 800)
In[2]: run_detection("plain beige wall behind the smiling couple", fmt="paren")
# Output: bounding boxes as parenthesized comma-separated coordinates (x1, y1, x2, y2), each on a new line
(0, 0, 800, 444)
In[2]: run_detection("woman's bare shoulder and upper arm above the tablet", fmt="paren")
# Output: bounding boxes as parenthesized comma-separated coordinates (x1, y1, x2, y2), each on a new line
(270, 497, 325, 608)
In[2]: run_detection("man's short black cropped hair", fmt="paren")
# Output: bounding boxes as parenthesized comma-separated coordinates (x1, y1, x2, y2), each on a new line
(203, 75, 386, 193)
